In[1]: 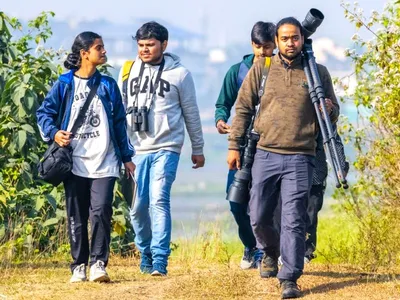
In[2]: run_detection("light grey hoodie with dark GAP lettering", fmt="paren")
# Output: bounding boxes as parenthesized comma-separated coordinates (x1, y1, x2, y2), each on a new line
(118, 53, 204, 155)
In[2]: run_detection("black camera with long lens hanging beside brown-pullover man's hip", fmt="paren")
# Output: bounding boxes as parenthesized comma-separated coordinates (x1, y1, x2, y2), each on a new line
(226, 126, 260, 204)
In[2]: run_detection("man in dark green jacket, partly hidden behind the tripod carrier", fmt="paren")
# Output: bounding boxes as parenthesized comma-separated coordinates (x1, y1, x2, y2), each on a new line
(215, 21, 275, 269)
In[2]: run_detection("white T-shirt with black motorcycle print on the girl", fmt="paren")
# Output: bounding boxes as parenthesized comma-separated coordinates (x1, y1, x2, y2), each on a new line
(67, 77, 119, 178)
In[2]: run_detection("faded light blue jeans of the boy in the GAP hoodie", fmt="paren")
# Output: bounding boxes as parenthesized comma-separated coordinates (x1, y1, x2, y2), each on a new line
(130, 150, 179, 267)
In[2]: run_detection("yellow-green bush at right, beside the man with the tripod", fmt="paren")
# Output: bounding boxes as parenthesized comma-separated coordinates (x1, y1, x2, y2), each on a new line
(336, 1, 400, 271)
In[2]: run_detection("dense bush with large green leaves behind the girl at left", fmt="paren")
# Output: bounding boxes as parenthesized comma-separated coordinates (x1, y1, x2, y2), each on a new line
(0, 12, 133, 260)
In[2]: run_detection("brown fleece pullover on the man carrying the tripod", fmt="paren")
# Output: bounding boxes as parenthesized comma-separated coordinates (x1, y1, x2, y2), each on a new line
(229, 55, 339, 155)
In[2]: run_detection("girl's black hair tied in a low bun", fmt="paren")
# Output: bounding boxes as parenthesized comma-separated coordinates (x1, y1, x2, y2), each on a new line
(64, 31, 101, 70)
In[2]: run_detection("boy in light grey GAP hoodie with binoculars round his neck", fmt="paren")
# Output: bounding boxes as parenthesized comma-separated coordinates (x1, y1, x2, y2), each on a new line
(119, 22, 205, 276)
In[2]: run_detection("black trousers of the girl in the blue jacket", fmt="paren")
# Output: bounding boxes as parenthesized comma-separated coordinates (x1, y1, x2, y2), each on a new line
(64, 175, 116, 271)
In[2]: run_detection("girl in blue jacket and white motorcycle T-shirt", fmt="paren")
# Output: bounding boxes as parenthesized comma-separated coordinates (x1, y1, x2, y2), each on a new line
(36, 32, 135, 282)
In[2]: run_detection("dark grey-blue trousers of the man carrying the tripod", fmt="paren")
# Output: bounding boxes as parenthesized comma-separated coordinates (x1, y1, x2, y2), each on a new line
(249, 149, 314, 281)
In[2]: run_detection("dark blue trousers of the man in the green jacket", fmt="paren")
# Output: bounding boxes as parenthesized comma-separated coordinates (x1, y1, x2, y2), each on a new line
(226, 170, 256, 249)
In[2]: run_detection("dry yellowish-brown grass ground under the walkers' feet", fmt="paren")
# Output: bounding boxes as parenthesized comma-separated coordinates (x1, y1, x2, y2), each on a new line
(0, 257, 400, 300)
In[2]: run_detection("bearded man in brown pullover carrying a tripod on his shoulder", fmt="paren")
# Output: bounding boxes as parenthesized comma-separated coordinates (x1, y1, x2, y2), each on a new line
(228, 17, 339, 299)
